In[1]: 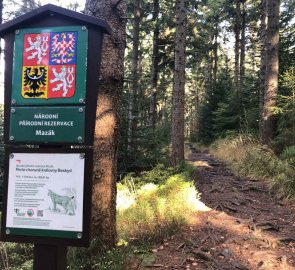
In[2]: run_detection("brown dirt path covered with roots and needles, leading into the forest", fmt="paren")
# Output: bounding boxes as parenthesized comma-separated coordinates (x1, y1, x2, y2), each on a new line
(139, 148, 295, 270)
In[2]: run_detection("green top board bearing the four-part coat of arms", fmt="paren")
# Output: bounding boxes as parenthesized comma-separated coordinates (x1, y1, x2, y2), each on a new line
(12, 27, 87, 104)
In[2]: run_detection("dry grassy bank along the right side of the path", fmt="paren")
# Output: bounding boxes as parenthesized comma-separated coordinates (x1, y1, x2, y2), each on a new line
(210, 136, 295, 199)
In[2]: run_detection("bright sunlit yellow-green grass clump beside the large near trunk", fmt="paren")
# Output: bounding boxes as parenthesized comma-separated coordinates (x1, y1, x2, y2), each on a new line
(117, 166, 199, 242)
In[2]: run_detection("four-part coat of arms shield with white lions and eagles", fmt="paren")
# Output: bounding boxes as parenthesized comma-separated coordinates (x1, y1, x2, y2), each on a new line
(22, 31, 78, 99)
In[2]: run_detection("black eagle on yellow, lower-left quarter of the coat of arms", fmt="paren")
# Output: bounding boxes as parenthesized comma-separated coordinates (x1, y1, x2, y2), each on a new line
(24, 67, 47, 97)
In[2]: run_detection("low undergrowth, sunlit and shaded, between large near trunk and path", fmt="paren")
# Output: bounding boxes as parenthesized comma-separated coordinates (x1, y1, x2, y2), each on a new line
(68, 164, 199, 270)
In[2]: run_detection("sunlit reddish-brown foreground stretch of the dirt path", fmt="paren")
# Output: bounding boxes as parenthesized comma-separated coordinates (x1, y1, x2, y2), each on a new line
(143, 198, 295, 270)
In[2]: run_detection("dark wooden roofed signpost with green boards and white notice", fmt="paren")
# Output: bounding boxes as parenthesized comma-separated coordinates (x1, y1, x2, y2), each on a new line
(0, 5, 110, 270)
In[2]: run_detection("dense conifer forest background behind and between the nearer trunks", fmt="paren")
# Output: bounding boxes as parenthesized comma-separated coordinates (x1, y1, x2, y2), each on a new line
(2, 0, 295, 174)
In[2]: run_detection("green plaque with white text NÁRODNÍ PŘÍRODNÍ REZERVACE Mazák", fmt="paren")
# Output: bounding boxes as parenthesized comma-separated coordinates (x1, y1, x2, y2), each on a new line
(9, 106, 85, 144)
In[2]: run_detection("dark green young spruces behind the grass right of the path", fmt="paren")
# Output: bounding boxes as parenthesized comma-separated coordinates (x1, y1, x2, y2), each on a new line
(198, 69, 259, 143)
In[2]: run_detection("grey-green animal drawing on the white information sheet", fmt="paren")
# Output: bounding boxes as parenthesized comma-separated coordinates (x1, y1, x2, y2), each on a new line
(48, 189, 77, 216)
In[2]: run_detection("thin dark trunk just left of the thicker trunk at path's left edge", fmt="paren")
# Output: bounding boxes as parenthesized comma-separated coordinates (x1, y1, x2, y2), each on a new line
(149, 0, 160, 131)
